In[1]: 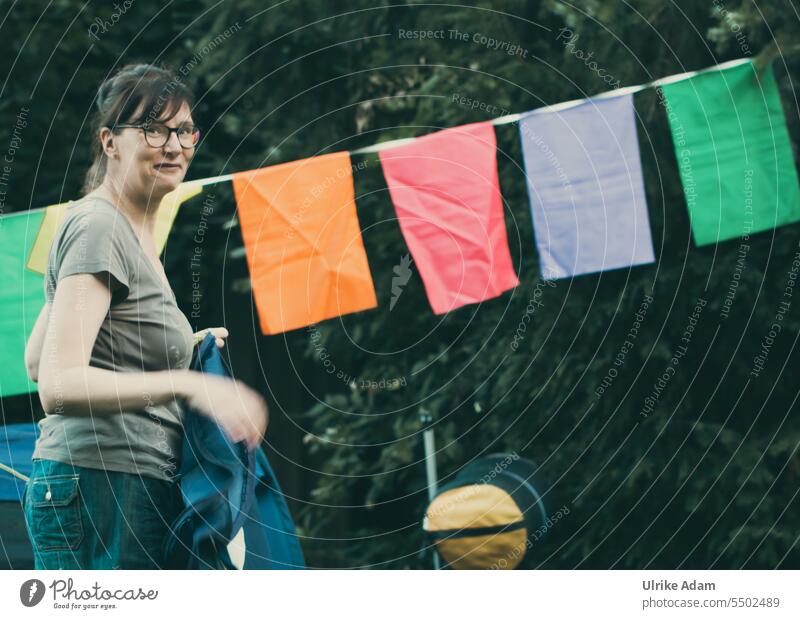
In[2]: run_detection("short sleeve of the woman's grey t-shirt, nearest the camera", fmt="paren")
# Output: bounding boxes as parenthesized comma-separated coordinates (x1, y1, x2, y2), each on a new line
(46, 205, 131, 305)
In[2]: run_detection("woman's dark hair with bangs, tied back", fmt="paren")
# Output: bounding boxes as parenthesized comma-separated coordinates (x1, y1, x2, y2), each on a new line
(83, 64, 194, 193)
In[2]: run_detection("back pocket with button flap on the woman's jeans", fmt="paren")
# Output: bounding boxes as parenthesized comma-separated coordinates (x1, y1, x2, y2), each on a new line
(25, 475, 83, 551)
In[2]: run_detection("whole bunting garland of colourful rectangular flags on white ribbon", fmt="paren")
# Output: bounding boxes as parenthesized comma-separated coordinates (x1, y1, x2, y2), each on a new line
(0, 59, 800, 397)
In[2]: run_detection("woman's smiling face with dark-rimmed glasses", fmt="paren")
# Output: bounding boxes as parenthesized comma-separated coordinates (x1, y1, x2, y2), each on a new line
(101, 103, 194, 201)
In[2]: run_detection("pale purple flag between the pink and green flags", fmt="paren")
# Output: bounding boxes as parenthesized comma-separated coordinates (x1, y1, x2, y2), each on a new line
(519, 95, 655, 279)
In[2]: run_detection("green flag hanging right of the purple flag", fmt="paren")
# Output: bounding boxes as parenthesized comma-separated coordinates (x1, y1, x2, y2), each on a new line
(662, 62, 800, 245)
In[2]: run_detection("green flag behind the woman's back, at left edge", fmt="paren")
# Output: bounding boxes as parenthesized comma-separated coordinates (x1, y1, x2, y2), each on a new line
(0, 210, 44, 397)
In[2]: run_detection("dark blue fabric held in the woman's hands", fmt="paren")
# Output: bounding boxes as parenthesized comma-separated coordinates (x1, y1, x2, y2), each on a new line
(165, 334, 305, 569)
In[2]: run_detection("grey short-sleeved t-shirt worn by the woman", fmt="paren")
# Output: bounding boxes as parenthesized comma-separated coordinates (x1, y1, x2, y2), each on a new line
(33, 198, 193, 479)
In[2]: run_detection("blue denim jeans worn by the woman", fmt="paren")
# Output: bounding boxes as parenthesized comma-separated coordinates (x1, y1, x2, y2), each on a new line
(23, 459, 183, 570)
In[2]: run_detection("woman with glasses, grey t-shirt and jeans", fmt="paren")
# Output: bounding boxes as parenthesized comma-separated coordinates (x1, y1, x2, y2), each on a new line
(25, 65, 268, 569)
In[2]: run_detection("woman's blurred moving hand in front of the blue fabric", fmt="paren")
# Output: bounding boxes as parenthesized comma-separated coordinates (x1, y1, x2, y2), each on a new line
(184, 372, 269, 449)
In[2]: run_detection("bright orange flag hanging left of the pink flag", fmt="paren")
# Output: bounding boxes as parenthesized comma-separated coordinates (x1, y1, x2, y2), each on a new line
(233, 152, 378, 335)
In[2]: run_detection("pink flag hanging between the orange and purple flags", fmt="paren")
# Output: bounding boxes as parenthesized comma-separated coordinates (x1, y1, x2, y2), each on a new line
(380, 123, 519, 314)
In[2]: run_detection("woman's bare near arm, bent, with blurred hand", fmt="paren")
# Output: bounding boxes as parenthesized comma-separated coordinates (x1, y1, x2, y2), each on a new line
(39, 273, 268, 448)
